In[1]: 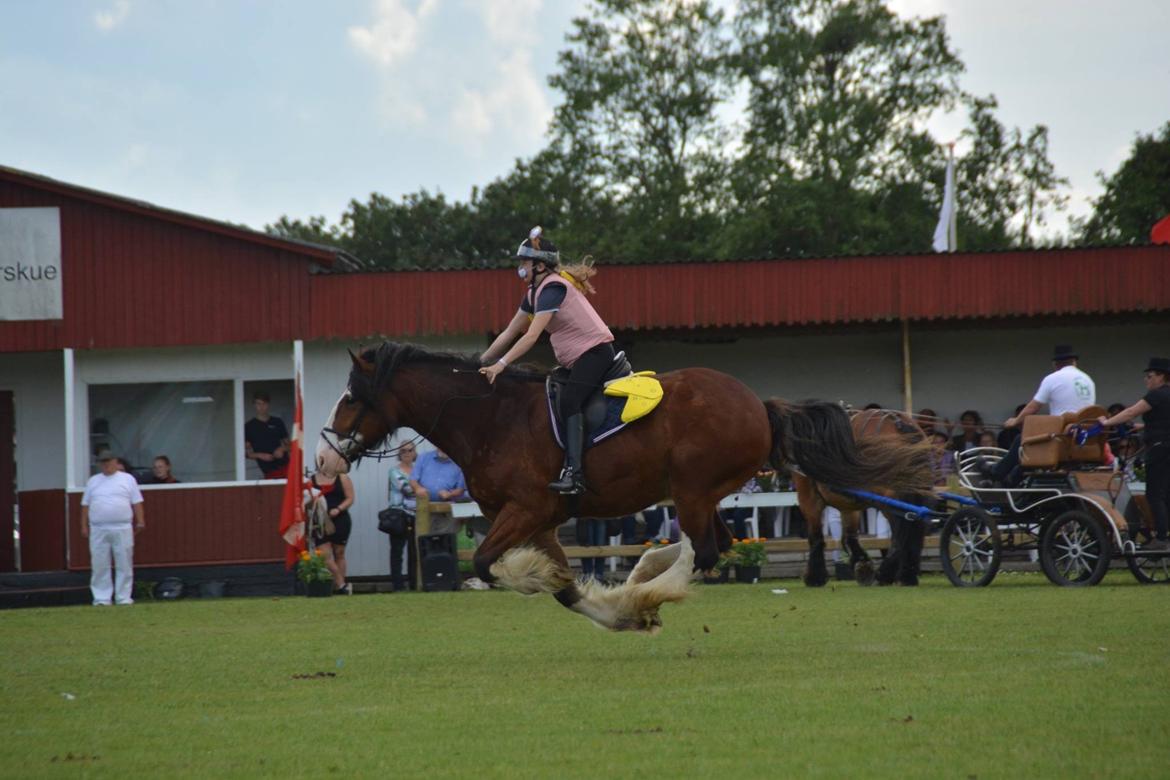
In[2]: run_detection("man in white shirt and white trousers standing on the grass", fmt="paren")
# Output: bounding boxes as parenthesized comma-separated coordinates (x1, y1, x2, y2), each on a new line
(81, 450, 146, 607)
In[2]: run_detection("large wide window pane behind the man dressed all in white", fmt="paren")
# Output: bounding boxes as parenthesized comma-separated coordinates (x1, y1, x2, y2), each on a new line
(89, 380, 235, 482)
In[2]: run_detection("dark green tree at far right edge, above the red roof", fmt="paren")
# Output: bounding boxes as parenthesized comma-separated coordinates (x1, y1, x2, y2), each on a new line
(1075, 122, 1170, 243)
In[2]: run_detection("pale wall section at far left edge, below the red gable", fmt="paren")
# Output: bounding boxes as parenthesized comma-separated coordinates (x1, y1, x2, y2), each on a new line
(0, 351, 66, 490)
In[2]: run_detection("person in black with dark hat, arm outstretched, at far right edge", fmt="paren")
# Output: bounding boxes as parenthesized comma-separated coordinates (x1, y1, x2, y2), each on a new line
(1097, 358, 1170, 550)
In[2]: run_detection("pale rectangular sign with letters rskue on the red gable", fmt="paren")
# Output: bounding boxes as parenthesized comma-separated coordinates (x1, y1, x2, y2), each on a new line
(0, 208, 63, 320)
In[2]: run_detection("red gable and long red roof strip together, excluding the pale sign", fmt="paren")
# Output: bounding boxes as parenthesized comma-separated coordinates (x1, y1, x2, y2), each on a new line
(0, 167, 1170, 352)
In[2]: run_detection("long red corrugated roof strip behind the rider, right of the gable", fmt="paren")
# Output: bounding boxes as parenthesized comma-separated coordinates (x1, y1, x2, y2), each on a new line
(309, 246, 1170, 338)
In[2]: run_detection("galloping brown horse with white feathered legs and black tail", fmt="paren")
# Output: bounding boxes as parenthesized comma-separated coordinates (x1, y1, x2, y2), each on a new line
(317, 343, 929, 630)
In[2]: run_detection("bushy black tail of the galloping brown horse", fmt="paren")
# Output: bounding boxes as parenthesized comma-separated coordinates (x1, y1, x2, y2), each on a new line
(764, 399, 932, 492)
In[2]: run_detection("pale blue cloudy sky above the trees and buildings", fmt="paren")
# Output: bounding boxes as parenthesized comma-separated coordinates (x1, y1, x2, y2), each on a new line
(0, 0, 1170, 240)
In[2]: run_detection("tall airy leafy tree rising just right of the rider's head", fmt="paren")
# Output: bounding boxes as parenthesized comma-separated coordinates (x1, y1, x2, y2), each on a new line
(549, 0, 730, 260)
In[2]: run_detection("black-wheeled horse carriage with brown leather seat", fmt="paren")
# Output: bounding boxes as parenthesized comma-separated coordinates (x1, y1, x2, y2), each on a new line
(938, 406, 1170, 587)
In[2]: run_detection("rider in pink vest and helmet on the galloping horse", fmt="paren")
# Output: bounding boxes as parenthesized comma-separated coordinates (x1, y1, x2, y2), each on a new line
(480, 227, 614, 495)
